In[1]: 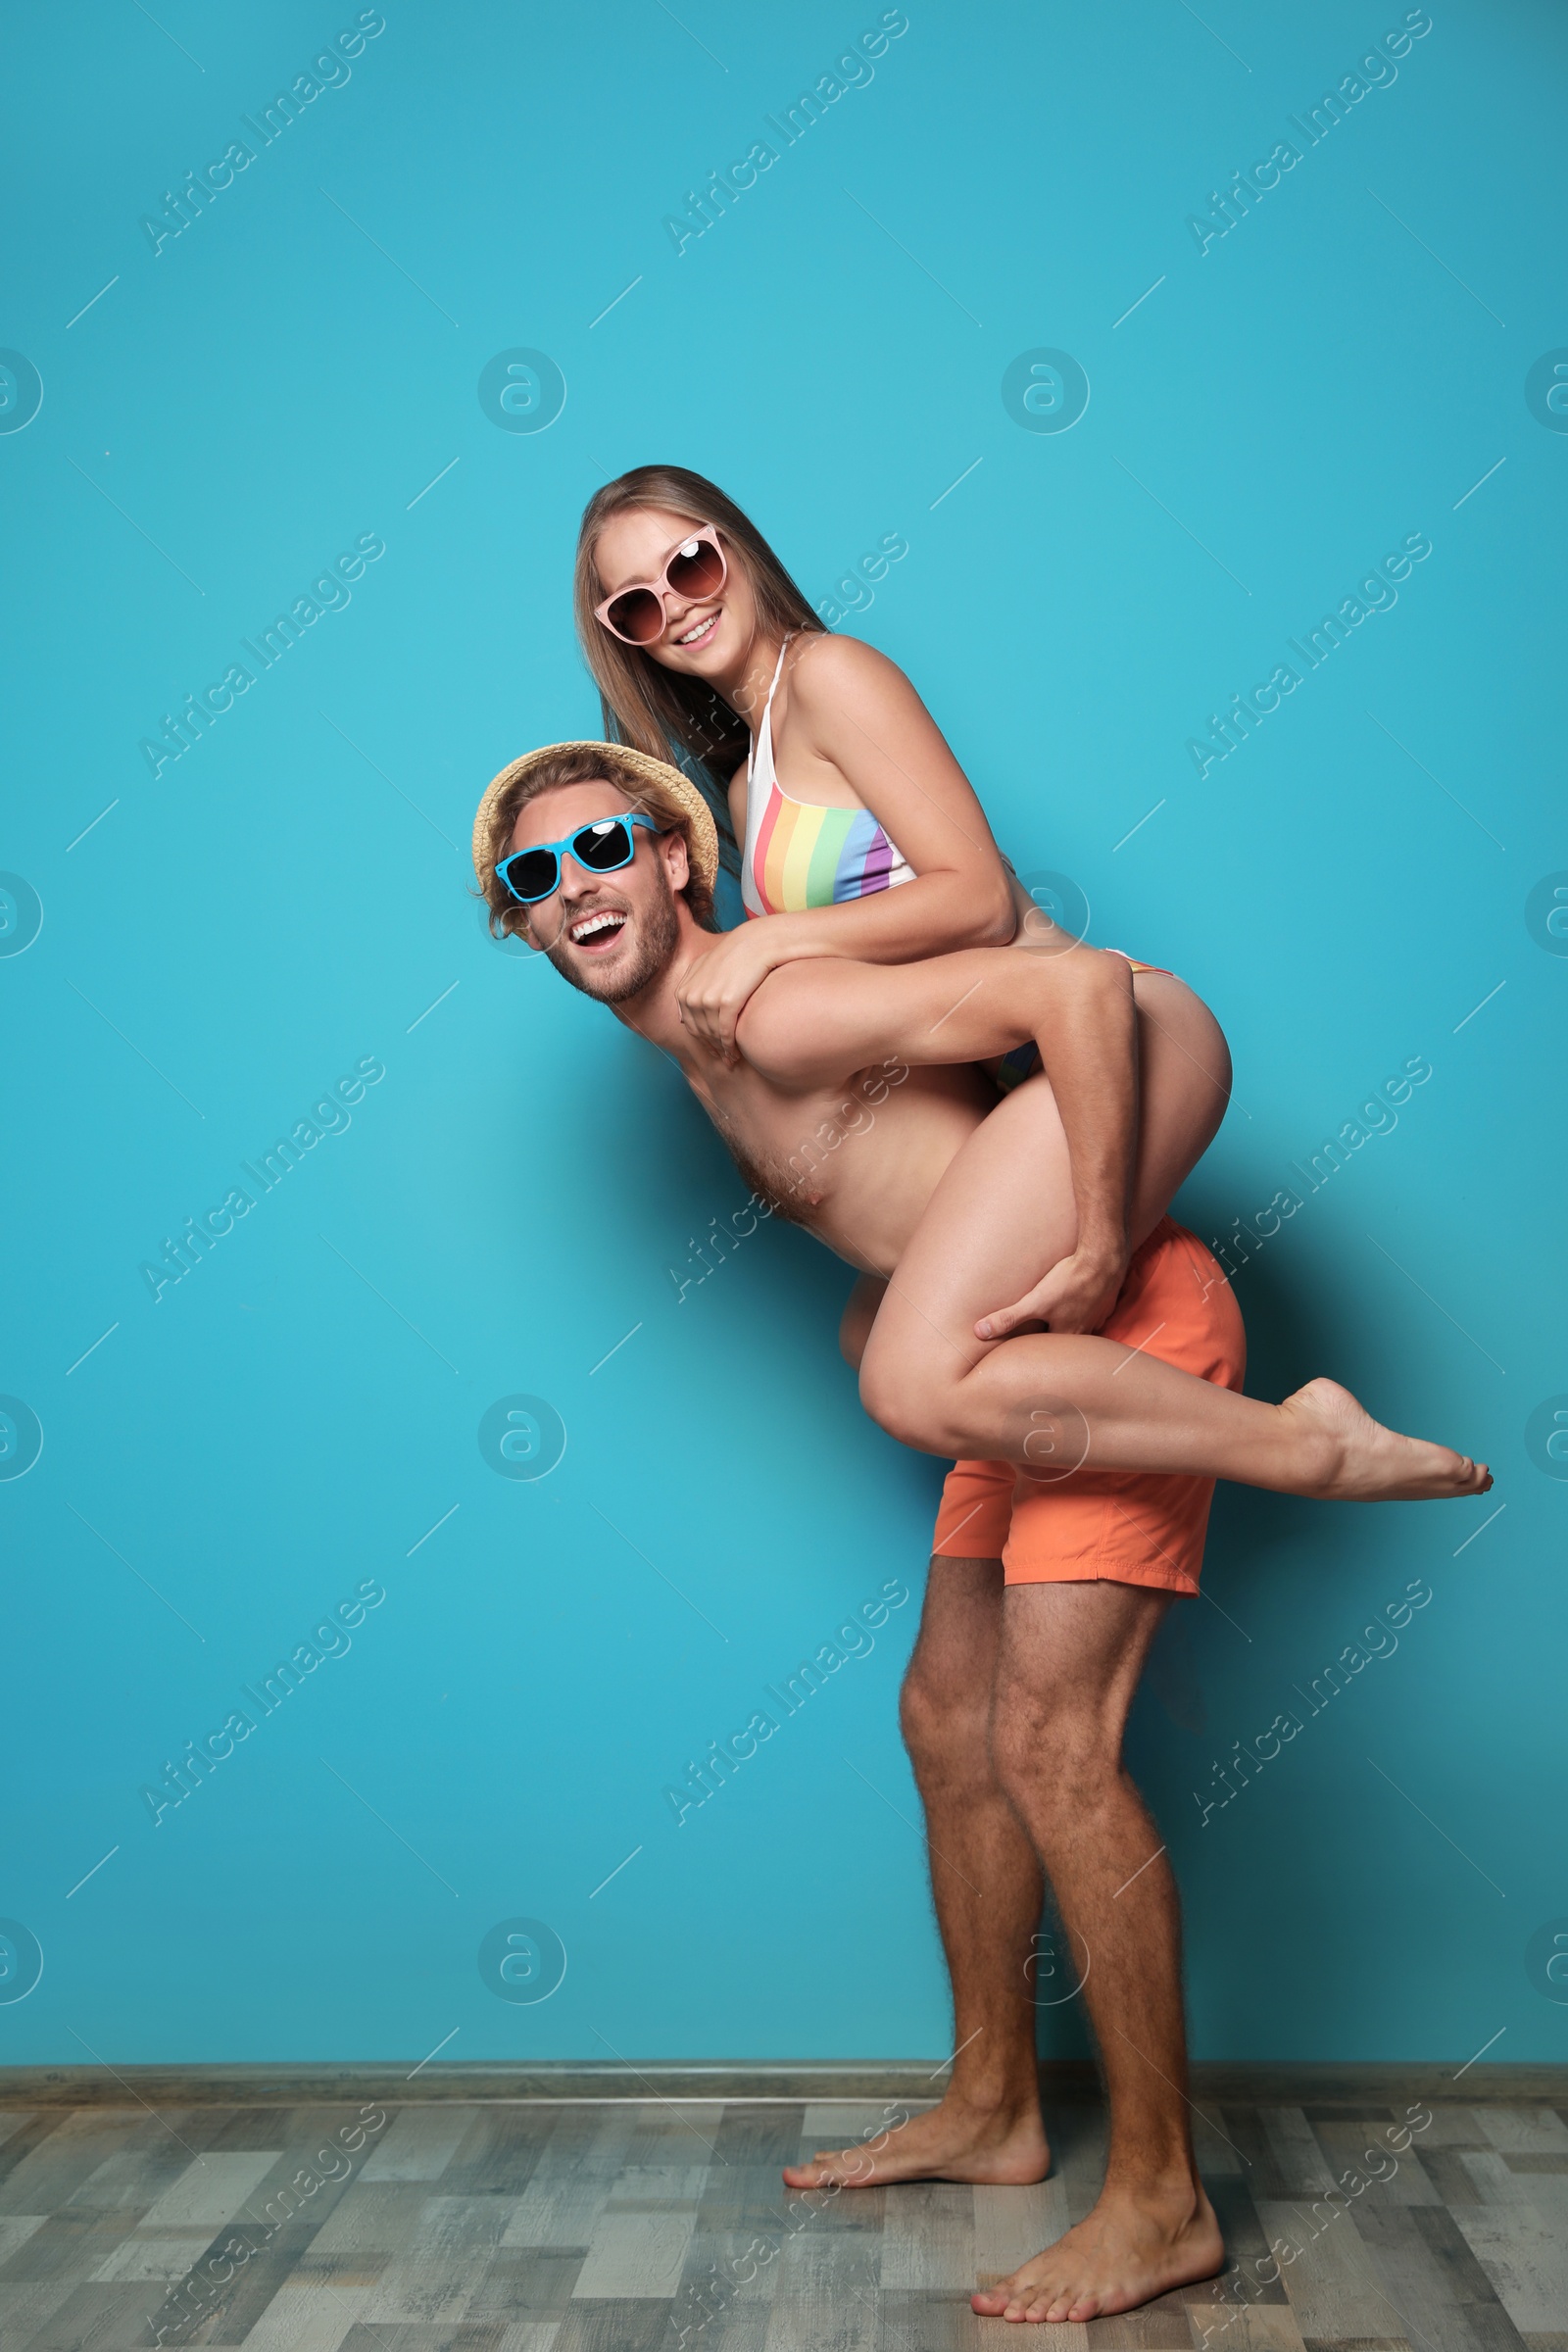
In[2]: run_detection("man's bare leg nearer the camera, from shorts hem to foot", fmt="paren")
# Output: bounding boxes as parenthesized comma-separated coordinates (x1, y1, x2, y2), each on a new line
(973, 1583, 1225, 2319)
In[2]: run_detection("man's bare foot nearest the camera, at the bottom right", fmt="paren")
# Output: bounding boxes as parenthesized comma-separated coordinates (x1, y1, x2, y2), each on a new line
(968, 2187, 1225, 2319)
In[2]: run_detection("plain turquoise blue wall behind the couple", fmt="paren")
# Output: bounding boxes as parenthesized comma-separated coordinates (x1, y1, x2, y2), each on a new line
(0, 0, 1568, 2065)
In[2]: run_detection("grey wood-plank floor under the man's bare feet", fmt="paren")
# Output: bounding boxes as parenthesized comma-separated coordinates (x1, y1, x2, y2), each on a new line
(0, 2100, 1568, 2352)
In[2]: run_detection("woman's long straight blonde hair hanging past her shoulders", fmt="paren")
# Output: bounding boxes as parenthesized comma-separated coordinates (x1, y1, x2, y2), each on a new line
(573, 466, 823, 872)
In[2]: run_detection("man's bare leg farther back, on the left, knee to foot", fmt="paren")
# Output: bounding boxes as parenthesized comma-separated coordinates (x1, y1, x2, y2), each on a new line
(785, 1554, 1051, 2187)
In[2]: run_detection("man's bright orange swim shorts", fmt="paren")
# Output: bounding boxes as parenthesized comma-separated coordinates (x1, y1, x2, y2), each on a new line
(931, 1216, 1246, 1594)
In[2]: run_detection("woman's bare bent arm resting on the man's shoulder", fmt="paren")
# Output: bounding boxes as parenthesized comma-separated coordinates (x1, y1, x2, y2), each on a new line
(682, 635, 1015, 1060)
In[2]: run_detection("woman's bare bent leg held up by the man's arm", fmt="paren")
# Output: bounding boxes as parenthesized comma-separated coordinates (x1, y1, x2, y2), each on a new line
(860, 974, 1491, 1500)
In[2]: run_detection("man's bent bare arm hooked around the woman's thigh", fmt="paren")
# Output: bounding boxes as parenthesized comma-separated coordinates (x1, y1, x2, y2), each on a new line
(736, 931, 1138, 1331)
